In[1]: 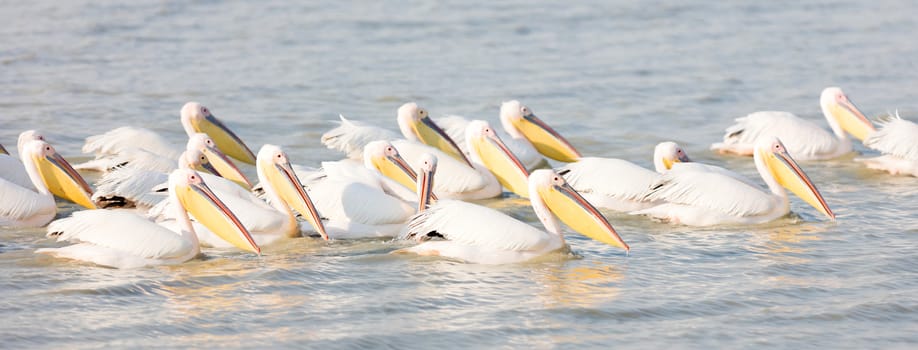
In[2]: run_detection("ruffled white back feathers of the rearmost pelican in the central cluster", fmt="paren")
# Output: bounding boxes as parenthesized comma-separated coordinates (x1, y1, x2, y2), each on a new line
(322, 115, 401, 159)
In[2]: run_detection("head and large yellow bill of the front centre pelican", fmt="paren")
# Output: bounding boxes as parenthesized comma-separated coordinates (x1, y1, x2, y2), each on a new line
(529, 169, 631, 250)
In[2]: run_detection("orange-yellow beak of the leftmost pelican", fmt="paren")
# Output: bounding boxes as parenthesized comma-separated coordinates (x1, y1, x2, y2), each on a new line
(35, 150, 97, 209)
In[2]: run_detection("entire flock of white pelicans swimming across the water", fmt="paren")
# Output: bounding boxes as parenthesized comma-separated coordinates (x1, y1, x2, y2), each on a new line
(0, 87, 918, 268)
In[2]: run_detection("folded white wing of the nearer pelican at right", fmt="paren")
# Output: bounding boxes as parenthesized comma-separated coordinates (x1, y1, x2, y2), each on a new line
(644, 168, 773, 216)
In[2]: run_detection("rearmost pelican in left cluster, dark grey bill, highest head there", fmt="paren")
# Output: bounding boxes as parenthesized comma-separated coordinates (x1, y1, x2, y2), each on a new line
(82, 102, 255, 170)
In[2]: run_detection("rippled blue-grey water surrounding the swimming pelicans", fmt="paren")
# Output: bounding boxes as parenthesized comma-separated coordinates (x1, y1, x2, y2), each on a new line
(0, 0, 918, 349)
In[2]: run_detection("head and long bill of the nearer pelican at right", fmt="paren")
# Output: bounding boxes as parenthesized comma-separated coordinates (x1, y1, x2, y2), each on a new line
(755, 137, 835, 220)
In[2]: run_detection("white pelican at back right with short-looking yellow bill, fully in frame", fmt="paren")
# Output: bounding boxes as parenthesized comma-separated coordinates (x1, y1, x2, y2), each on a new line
(711, 87, 874, 160)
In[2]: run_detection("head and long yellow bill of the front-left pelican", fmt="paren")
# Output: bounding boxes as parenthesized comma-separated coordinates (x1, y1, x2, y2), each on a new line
(169, 169, 261, 254)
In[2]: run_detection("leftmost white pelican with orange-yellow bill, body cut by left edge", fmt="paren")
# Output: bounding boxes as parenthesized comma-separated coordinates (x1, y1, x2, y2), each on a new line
(0, 140, 95, 227)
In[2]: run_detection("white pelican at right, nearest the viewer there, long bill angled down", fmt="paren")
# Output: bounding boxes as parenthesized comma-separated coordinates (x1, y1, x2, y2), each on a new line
(634, 137, 835, 226)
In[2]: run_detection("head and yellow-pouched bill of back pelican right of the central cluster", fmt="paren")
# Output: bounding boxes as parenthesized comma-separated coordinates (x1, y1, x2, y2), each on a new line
(500, 100, 581, 163)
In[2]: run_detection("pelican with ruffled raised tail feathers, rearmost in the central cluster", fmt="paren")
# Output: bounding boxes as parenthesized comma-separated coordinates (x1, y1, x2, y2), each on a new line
(322, 102, 472, 167)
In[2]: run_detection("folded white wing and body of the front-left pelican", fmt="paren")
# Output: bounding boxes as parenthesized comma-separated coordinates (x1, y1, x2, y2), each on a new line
(48, 210, 193, 259)
